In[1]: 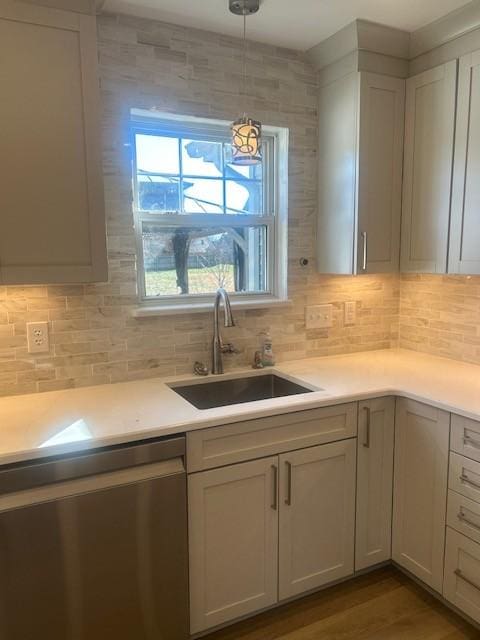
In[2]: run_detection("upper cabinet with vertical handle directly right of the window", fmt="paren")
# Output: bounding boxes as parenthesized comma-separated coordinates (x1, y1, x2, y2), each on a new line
(317, 72, 405, 274)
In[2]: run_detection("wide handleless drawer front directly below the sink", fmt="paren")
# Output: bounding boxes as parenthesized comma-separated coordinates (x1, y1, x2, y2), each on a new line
(187, 402, 357, 472)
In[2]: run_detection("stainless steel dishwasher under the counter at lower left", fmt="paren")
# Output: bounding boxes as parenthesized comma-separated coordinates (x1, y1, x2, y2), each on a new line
(0, 437, 188, 640)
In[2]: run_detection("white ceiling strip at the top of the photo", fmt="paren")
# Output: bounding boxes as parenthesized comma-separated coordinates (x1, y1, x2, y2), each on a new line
(104, 0, 470, 50)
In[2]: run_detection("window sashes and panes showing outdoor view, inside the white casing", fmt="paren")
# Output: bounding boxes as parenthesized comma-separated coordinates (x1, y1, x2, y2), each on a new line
(134, 127, 271, 297)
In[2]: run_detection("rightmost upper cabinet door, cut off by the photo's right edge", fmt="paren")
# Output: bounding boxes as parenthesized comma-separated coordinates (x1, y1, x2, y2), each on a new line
(448, 51, 480, 273)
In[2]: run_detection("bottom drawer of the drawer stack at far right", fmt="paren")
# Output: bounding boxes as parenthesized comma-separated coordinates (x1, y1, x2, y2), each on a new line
(443, 528, 480, 622)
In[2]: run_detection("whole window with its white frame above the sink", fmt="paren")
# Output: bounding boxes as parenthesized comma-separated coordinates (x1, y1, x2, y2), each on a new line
(131, 110, 288, 306)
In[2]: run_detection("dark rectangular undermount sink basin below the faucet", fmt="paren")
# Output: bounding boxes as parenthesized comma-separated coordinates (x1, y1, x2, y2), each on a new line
(171, 373, 314, 409)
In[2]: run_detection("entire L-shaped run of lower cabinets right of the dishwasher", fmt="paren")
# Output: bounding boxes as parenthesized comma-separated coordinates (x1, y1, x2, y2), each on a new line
(188, 397, 480, 634)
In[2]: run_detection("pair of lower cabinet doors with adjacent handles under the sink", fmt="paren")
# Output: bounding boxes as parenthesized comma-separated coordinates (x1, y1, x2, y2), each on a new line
(188, 439, 356, 634)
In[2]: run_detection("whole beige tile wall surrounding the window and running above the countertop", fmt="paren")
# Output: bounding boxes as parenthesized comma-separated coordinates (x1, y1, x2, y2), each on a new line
(0, 15, 480, 395)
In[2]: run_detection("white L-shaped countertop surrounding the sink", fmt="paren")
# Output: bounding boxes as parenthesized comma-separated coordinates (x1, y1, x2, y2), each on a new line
(0, 349, 480, 464)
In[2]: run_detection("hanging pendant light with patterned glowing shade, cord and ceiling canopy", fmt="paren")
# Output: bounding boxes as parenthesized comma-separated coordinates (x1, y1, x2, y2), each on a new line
(229, 0, 262, 165)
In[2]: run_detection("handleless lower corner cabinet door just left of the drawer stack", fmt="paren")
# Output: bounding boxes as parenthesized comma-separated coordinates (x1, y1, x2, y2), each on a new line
(392, 398, 450, 592)
